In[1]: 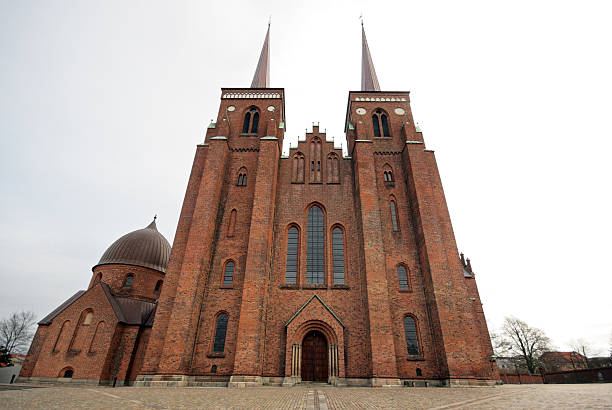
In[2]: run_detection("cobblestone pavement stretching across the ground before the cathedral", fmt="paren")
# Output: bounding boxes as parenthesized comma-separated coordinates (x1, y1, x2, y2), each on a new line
(0, 384, 612, 410)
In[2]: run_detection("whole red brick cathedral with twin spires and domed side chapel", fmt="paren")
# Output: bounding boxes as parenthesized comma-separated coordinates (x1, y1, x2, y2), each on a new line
(20, 26, 499, 388)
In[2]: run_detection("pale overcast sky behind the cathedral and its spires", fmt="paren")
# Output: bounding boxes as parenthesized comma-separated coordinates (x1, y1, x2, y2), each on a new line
(0, 0, 612, 353)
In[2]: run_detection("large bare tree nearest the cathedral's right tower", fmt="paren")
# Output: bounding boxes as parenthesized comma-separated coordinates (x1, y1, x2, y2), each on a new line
(502, 317, 551, 374)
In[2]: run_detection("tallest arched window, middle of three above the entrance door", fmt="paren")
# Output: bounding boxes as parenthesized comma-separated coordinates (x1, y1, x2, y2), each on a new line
(306, 205, 325, 284)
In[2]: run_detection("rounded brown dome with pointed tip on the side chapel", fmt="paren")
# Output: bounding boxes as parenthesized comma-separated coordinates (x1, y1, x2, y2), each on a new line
(94, 219, 172, 273)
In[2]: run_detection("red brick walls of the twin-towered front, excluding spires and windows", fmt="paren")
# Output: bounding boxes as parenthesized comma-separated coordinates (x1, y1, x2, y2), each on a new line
(137, 88, 499, 387)
